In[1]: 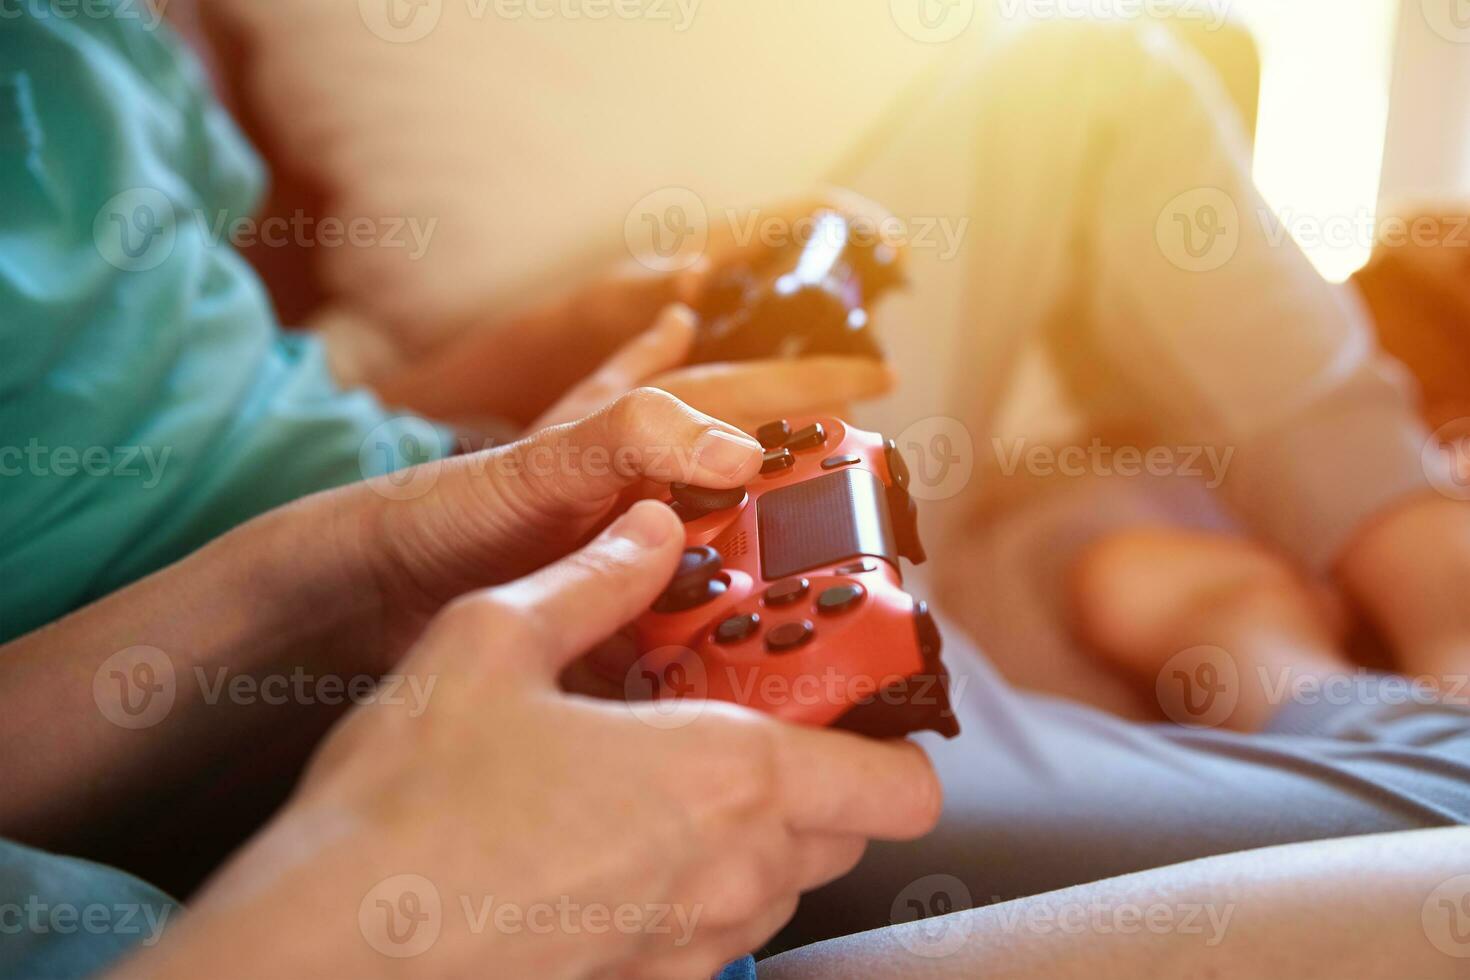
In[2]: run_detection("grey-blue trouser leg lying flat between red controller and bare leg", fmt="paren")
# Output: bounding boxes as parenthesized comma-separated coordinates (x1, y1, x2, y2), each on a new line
(782, 614, 1470, 945)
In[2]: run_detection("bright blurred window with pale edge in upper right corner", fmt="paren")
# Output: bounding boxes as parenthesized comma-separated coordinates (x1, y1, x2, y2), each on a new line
(1233, 0, 1470, 281)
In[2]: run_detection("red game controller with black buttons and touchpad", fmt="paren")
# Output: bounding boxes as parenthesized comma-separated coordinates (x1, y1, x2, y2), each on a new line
(592, 419, 960, 738)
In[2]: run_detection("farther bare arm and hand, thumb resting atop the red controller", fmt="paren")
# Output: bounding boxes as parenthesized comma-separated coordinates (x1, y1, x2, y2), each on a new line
(0, 391, 760, 848)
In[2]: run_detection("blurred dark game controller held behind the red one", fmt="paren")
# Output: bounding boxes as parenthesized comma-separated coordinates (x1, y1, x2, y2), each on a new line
(689, 212, 904, 364)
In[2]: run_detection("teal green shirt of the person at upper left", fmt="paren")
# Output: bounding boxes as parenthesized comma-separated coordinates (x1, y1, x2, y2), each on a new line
(0, 0, 445, 641)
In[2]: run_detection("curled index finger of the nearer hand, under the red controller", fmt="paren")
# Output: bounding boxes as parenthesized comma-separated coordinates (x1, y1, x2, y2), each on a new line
(778, 726, 944, 840)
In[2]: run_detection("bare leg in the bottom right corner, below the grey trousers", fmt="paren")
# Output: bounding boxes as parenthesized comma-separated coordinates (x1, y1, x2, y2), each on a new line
(760, 829, 1470, 980)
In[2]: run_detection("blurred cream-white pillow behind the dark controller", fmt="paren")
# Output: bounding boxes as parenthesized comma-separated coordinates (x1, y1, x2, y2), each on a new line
(212, 0, 942, 364)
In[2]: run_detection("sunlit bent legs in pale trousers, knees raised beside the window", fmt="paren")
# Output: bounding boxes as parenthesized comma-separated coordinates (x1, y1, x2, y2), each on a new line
(853, 22, 1432, 574)
